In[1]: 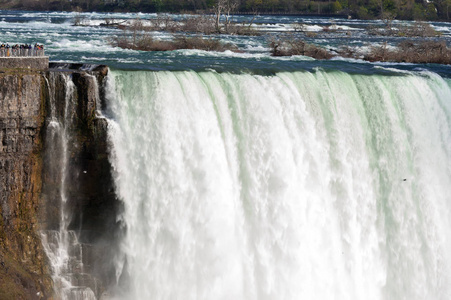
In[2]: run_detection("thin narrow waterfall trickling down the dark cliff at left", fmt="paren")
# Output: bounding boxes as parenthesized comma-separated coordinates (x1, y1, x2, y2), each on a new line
(41, 72, 96, 300)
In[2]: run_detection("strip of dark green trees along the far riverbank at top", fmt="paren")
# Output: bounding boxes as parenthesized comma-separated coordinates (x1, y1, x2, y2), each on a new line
(0, 0, 451, 20)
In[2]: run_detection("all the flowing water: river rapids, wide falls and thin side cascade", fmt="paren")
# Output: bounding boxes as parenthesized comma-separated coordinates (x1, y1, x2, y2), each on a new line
(0, 11, 451, 300)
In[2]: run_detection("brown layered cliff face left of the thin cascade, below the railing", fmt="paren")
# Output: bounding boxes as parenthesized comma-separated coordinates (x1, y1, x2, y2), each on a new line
(0, 71, 52, 299)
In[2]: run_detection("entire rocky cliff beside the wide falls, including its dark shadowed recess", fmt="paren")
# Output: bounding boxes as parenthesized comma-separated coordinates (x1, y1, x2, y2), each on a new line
(0, 66, 120, 299)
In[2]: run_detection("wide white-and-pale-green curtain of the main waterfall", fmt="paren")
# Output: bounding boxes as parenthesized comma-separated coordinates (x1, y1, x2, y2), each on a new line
(108, 70, 451, 299)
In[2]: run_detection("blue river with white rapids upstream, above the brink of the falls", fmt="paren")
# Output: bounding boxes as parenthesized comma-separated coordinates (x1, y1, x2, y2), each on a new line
(0, 11, 451, 75)
